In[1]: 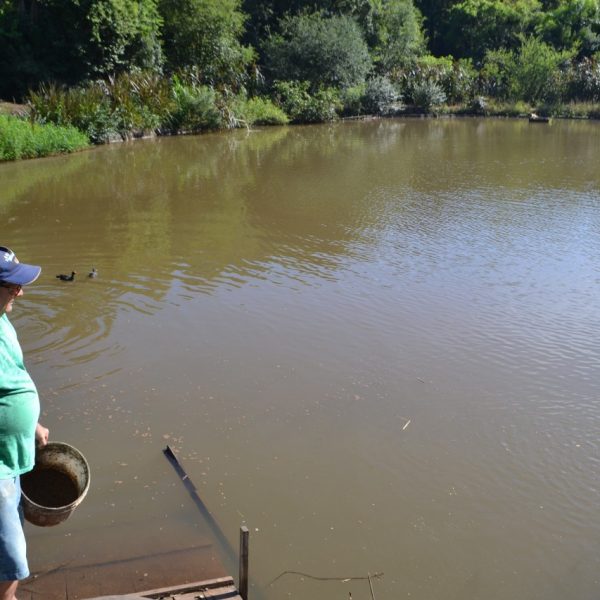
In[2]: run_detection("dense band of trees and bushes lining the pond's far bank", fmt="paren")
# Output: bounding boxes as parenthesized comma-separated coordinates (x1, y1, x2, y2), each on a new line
(0, 0, 600, 157)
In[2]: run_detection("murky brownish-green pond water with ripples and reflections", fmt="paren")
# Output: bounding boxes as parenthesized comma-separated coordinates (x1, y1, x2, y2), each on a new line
(0, 119, 600, 600)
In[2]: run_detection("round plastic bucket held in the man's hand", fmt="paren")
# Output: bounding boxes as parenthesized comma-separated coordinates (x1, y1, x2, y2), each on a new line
(21, 442, 90, 527)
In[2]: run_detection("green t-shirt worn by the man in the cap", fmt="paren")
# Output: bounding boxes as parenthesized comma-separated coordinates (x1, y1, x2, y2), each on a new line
(0, 314, 40, 479)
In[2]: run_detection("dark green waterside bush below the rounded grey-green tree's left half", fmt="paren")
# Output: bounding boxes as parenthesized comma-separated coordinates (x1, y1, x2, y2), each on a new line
(274, 81, 341, 123)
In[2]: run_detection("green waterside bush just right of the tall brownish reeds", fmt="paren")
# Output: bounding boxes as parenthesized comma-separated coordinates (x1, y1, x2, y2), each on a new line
(169, 77, 222, 132)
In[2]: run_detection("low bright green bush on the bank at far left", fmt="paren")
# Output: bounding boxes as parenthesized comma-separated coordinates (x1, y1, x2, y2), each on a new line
(0, 115, 90, 161)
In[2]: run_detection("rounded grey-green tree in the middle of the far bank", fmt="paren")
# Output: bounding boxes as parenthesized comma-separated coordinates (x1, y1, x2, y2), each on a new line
(264, 13, 372, 90)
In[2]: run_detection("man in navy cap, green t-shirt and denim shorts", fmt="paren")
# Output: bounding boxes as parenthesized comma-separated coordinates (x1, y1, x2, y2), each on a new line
(0, 246, 48, 600)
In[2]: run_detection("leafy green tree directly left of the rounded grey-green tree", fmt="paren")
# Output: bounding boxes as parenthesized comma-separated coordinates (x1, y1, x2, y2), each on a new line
(159, 0, 254, 85)
